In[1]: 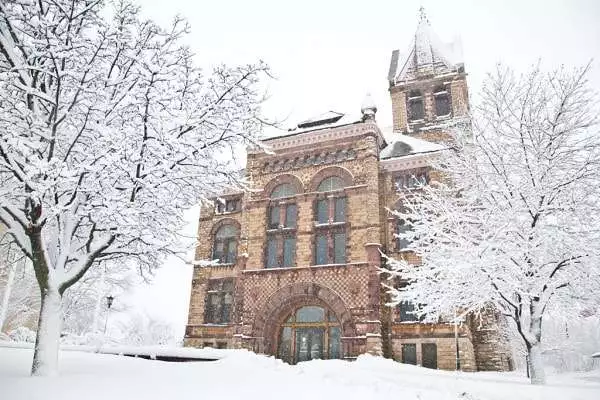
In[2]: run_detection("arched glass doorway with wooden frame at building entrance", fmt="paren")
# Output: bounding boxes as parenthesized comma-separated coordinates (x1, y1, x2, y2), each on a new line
(277, 305, 342, 364)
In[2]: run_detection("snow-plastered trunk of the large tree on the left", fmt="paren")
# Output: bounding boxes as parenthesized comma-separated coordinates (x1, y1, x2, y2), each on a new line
(31, 287, 62, 376)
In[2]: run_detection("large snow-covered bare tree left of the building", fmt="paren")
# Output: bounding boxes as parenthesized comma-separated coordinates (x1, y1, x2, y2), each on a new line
(0, 0, 268, 375)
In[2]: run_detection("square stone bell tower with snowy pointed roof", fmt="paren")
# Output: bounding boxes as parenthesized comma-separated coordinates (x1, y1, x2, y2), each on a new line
(388, 7, 469, 142)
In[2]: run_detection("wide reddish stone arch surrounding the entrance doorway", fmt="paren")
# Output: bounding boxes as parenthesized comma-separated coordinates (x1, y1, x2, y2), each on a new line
(253, 282, 356, 354)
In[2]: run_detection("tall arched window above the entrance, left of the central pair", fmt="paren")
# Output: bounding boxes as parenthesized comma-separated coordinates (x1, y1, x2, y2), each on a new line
(265, 183, 298, 268)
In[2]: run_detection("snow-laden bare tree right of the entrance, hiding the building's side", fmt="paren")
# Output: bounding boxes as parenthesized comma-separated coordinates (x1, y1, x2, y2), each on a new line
(391, 67, 600, 383)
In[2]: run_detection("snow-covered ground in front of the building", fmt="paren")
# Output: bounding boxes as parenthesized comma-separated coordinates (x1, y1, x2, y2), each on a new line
(0, 348, 600, 400)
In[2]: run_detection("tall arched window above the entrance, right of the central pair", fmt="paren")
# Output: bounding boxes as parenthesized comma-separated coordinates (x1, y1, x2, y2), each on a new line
(314, 176, 346, 265)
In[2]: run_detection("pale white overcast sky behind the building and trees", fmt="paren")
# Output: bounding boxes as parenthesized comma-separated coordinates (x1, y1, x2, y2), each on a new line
(120, 0, 600, 335)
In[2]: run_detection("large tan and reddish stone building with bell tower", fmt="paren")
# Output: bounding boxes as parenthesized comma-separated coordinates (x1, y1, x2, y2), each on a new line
(185, 10, 510, 371)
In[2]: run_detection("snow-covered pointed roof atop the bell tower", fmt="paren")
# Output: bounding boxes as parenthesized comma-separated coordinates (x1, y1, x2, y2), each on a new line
(388, 10, 464, 85)
